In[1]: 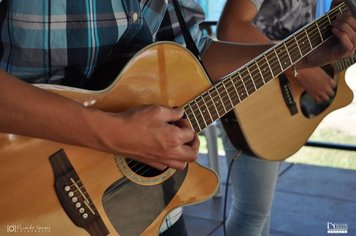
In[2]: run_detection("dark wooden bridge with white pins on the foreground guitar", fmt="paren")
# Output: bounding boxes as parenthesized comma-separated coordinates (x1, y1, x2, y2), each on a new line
(49, 149, 109, 235)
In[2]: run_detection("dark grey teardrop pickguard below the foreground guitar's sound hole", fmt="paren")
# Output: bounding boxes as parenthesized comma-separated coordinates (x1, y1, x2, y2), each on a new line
(103, 167, 188, 236)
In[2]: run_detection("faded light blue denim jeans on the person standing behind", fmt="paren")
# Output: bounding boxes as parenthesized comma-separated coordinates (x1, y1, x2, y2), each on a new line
(220, 126, 281, 236)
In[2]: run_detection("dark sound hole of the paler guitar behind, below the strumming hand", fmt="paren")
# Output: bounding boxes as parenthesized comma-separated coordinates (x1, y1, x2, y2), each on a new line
(300, 92, 334, 118)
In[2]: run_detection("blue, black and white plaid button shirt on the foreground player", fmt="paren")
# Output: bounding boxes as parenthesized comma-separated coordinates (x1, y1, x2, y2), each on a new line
(0, 0, 208, 84)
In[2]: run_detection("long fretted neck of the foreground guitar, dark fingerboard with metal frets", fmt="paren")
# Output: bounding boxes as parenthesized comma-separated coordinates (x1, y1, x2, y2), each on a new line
(183, 3, 347, 133)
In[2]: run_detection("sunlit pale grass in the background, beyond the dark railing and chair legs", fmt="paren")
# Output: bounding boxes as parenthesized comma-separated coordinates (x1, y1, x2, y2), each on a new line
(199, 129, 356, 170)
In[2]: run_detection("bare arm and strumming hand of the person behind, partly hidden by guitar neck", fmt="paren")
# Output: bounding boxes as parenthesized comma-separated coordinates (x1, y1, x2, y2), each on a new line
(217, 0, 344, 102)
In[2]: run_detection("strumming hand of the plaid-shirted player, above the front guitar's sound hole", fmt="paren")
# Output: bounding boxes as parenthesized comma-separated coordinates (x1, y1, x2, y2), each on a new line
(95, 105, 199, 170)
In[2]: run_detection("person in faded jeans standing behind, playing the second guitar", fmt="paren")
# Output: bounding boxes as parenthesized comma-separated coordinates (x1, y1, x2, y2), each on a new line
(217, 0, 336, 236)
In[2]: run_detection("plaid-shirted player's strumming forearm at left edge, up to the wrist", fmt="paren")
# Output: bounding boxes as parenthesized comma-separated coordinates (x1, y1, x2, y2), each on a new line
(0, 72, 112, 149)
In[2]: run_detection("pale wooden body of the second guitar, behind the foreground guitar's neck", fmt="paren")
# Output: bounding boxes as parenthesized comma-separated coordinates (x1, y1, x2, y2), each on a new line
(221, 71, 353, 161)
